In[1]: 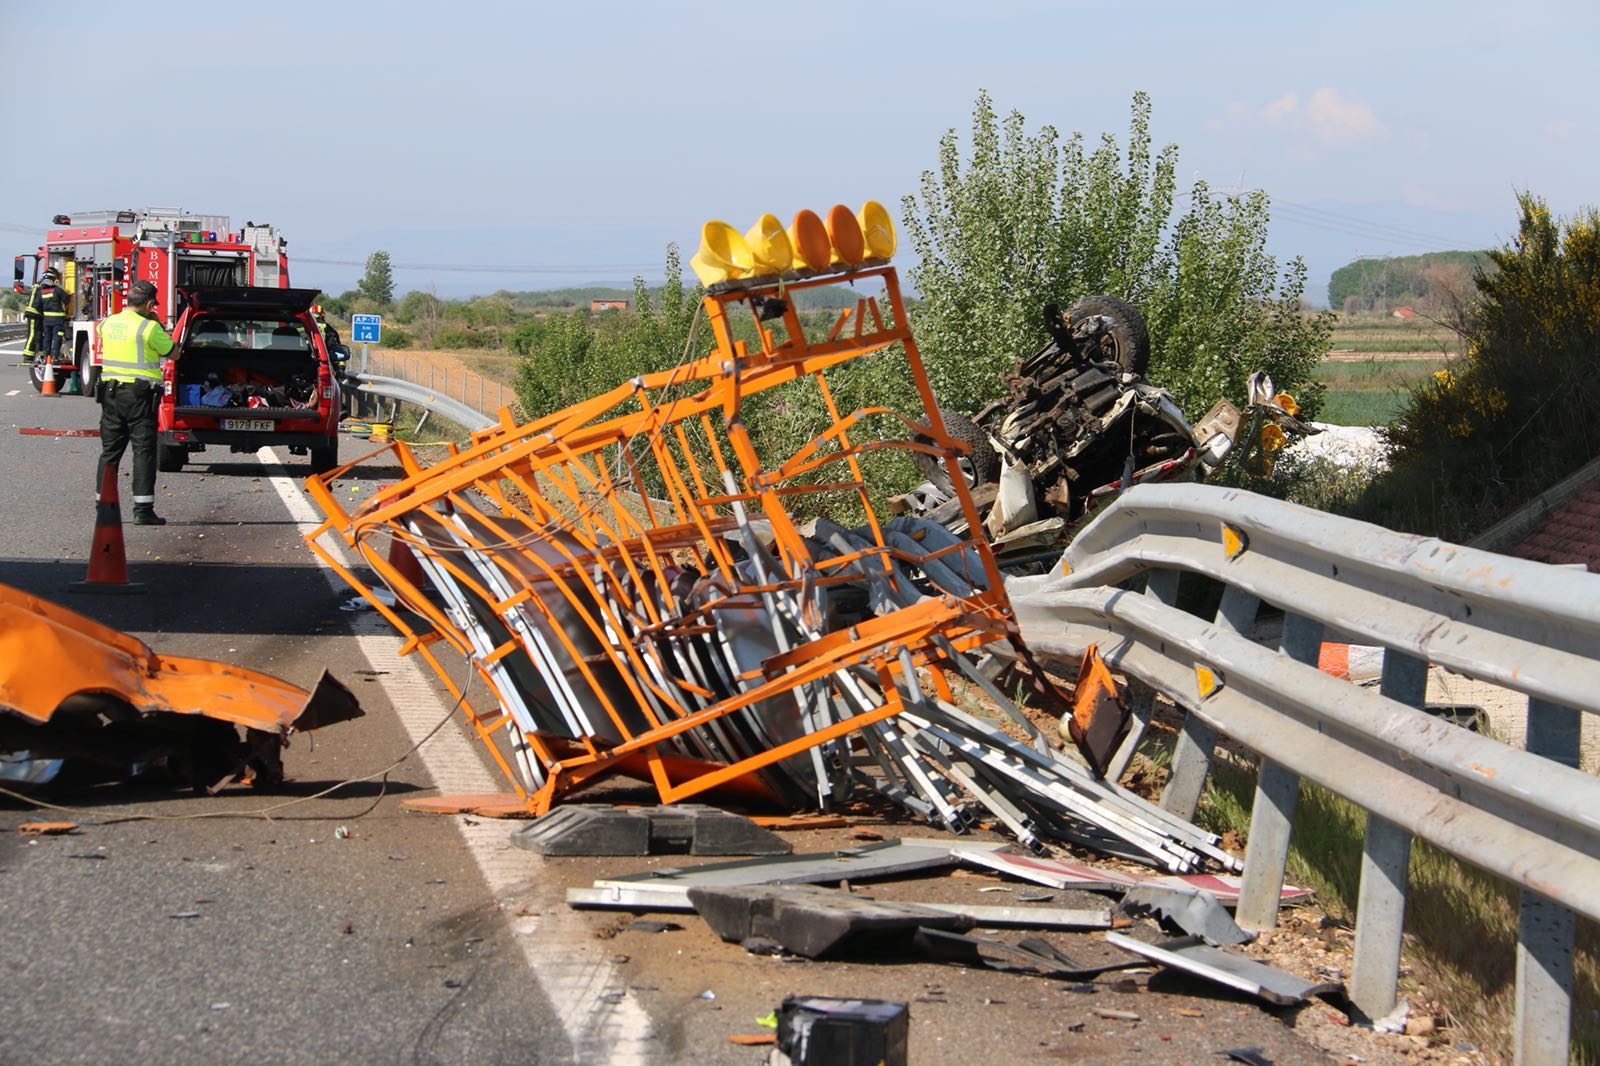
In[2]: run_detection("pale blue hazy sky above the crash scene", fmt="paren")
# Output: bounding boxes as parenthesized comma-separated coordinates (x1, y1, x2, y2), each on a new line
(0, 0, 1600, 295)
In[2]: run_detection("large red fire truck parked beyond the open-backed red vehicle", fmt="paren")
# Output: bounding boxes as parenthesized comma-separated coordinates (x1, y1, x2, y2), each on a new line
(11, 208, 290, 395)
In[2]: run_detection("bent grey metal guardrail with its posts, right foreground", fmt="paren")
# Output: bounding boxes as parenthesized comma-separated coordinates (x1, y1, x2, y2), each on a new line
(1008, 485, 1600, 1063)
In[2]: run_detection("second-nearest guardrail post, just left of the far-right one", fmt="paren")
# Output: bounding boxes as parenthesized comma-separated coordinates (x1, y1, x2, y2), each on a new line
(1350, 648, 1427, 1020)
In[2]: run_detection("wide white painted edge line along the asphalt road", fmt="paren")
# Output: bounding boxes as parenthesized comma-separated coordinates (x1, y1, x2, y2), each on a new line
(256, 448, 654, 1066)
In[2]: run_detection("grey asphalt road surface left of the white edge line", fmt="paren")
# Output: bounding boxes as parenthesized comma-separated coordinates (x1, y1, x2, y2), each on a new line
(0, 382, 604, 1063)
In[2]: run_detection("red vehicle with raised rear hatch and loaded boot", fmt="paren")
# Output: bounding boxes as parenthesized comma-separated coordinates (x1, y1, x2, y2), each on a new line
(157, 287, 341, 474)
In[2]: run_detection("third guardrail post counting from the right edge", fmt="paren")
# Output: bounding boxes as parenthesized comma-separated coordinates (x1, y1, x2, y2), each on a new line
(1235, 615, 1322, 928)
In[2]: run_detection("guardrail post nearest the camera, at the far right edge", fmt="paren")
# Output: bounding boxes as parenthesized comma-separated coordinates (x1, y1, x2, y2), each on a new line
(1515, 698, 1582, 1066)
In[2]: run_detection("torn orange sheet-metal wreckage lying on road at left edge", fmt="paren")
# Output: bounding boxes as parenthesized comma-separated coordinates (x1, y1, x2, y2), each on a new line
(0, 586, 362, 786)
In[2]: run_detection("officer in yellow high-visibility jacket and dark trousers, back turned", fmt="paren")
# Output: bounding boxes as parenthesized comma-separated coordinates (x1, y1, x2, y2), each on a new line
(94, 282, 173, 525)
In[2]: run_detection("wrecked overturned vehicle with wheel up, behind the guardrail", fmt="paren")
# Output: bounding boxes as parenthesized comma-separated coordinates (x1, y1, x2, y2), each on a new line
(893, 296, 1317, 573)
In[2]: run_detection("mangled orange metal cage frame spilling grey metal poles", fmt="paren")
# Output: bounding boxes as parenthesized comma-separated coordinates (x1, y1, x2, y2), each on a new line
(307, 266, 1237, 871)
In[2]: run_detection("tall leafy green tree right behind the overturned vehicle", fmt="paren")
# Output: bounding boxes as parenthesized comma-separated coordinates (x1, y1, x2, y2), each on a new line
(902, 93, 1331, 413)
